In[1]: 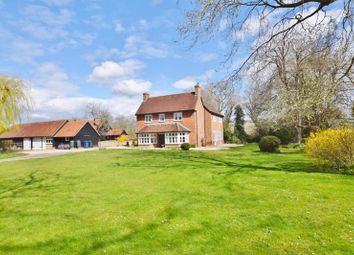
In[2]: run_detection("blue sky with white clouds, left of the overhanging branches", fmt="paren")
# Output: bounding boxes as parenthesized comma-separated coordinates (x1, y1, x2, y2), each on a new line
(0, 0, 241, 122)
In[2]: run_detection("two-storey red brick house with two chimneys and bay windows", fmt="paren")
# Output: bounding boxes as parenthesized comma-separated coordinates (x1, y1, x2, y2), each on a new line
(136, 84, 224, 147)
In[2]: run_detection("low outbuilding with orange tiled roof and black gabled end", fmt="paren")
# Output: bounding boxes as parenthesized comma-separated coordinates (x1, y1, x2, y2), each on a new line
(0, 119, 100, 150)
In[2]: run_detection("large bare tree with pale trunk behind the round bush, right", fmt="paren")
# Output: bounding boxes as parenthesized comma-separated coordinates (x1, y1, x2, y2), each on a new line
(250, 20, 354, 142)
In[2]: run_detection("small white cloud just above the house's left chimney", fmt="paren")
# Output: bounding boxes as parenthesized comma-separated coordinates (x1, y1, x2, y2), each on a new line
(112, 79, 151, 96)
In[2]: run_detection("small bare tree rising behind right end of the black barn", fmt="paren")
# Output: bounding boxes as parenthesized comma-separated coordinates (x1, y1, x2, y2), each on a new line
(86, 103, 113, 136)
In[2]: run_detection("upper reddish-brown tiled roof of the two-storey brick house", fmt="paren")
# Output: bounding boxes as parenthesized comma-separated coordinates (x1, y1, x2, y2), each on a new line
(136, 92, 223, 117)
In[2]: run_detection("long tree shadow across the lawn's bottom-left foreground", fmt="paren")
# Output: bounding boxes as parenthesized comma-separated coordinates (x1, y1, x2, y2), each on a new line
(0, 199, 205, 255)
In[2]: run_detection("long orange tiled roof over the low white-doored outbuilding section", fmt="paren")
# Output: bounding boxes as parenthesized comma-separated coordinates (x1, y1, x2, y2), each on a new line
(0, 120, 67, 139)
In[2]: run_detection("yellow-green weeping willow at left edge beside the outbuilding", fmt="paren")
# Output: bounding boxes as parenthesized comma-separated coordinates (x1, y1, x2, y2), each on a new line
(0, 75, 31, 133)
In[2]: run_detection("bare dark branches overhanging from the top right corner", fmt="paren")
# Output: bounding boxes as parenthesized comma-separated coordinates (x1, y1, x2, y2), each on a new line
(179, 0, 354, 79)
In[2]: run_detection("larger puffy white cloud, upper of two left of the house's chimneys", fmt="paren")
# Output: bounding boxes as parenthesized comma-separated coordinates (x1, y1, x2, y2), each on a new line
(88, 59, 144, 84)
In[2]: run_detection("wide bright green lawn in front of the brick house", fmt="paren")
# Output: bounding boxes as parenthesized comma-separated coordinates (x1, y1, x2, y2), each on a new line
(0, 145, 354, 255)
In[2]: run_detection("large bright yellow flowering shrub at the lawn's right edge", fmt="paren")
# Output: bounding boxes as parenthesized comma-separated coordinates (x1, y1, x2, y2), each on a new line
(305, 127, 354, 169)
